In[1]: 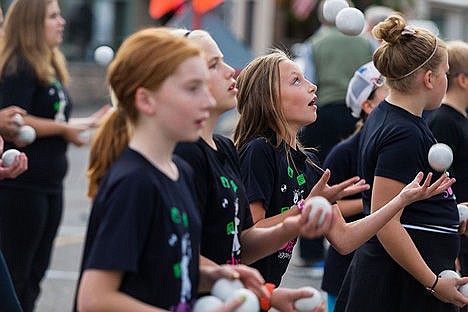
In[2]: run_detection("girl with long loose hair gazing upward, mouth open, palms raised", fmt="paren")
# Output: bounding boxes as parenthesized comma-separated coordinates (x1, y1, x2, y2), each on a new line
(234, 50, 454, 290)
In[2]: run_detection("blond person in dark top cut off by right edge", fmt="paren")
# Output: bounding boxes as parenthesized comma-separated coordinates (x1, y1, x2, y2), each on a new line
(427, 41, 468, 311)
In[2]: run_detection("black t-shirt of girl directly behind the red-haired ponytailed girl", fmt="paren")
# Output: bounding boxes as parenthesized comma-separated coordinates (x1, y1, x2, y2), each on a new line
(175, 135, 253, 264)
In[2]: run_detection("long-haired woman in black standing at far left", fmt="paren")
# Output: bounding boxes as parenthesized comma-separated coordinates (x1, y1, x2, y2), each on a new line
(0, 0, 109, 312)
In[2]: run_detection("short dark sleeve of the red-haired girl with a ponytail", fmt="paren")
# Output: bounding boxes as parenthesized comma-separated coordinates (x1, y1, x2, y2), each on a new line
(85, 172, 157, 272)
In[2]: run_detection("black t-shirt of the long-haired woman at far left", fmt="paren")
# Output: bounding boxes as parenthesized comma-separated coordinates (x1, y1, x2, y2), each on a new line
(0, 59, 72, 192)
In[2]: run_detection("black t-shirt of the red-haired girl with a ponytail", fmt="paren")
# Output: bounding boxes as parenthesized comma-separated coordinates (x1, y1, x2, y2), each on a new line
(77, 149, 201, 311)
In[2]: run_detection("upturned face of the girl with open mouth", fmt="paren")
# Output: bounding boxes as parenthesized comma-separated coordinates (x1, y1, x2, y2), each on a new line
(279, 60, 317, 129)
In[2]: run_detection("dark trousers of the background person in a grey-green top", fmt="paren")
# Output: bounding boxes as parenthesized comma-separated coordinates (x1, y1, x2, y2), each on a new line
(299, 100, 357, 261)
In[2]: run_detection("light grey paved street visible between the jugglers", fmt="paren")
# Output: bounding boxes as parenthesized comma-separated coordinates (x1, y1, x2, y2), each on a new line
(36, 107, 326, 312)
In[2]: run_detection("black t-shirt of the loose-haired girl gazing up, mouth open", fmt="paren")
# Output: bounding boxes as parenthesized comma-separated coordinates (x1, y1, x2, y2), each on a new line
(239, 133, 322, 285)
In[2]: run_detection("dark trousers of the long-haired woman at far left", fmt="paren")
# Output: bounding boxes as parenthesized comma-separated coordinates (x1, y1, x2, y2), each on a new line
(0, 188, 63, 312)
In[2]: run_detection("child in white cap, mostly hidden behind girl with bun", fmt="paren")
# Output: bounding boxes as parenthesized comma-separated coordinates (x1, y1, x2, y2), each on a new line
(322, 62, 388, 311)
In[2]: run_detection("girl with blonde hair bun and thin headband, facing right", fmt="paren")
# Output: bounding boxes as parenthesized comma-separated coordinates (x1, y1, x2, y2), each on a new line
(335, 15, 468, 312)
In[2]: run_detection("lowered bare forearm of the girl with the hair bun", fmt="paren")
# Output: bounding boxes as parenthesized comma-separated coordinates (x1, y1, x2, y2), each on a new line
(377, 220, 436, 287)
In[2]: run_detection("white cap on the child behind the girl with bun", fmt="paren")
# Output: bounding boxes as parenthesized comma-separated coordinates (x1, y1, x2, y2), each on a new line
(346, 62, 384, 118)
